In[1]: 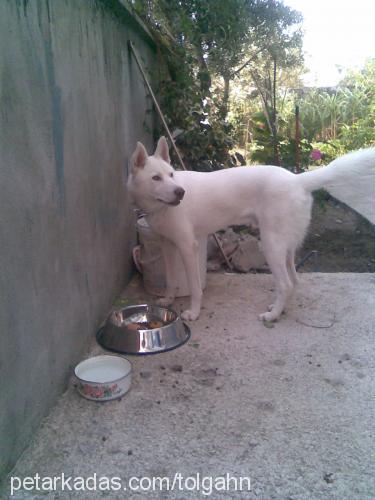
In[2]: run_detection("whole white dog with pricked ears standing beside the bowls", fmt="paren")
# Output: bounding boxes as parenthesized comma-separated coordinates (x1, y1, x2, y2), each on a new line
(128, 137, 375, 321)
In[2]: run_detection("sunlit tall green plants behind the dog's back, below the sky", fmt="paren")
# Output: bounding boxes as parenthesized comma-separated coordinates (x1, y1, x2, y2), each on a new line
(231, 59, 375, 168)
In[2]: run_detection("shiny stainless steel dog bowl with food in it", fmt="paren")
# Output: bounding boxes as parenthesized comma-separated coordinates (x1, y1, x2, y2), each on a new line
(96, 304, 190, 354)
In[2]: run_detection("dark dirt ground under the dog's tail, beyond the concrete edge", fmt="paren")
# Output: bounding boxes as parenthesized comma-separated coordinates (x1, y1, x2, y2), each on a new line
(296, 195, 375, 273)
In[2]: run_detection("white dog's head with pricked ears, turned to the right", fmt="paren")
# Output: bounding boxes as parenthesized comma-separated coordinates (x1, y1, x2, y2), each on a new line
(128, 137, 185, 213)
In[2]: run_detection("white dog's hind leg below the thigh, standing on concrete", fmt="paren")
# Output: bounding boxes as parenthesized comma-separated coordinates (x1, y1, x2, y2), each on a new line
(259, 237, 294, 321)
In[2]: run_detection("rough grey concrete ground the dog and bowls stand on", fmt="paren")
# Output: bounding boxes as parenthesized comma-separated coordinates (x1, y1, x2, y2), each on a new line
(4, 274, 375, 500)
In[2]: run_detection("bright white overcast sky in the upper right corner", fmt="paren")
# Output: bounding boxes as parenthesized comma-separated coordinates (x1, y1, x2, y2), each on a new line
(284, 0, 375, 87)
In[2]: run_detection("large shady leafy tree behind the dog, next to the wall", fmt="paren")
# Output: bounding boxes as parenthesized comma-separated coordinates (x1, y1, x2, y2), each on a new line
(134, 0, 301, 170)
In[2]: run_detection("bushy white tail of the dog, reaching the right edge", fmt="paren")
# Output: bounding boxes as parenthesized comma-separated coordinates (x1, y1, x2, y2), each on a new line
(298, 148, 375, 224)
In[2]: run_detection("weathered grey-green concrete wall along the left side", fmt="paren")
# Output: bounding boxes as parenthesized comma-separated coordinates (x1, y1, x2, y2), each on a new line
(0, 0, 154, 476)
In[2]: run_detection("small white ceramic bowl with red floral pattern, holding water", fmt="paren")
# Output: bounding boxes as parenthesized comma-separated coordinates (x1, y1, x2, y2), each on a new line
(74, 355, 132, 401)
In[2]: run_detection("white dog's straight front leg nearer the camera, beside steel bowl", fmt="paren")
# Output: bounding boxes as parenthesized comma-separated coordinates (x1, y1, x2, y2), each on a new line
(178, 238, 202, 321)
